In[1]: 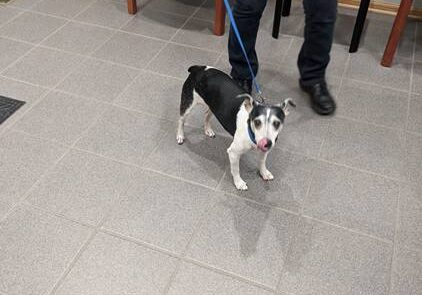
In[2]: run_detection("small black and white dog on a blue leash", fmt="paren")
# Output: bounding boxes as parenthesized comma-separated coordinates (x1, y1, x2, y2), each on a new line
(177, 66, 295, 190)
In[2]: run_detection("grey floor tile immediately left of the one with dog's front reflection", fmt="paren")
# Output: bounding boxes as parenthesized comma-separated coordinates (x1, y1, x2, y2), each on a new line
(104, 172, 217, 254)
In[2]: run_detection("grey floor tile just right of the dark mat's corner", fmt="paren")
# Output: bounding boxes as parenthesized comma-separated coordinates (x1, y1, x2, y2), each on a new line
(15, 92, 106, 145)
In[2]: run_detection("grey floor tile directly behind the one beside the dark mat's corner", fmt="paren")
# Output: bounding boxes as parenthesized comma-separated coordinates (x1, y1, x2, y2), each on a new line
(57, 59, 139, 102)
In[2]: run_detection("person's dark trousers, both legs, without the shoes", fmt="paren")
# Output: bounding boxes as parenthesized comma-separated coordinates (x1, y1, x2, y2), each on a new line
(229, 0, 337, 85)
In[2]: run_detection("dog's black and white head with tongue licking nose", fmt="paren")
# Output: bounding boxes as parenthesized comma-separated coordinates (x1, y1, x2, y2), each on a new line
(244, 96, 296, 152)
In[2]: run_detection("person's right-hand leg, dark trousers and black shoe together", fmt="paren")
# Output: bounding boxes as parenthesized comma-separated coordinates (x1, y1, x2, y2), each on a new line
(298, 0, 337, 115)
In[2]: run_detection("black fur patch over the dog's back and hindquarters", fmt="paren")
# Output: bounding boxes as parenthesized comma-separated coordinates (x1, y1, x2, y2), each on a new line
(180, 66, 245, 136)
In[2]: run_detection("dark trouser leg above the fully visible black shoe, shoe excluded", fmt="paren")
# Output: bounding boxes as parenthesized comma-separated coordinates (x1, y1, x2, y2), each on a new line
(298, 0, 337, 86)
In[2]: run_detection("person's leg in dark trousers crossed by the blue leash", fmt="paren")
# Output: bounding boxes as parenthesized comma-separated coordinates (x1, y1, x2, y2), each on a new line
(228, 0, 267, 91)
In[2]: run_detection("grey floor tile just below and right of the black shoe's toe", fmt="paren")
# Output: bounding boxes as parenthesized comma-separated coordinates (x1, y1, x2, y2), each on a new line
(321, 119, 406, 180)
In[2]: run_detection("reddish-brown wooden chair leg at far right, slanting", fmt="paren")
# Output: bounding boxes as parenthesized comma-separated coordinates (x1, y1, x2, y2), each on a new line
(381, 0, 413, 67)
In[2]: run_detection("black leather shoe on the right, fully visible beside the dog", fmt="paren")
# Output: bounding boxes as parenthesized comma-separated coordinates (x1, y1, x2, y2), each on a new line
(299, 82, 336, 115)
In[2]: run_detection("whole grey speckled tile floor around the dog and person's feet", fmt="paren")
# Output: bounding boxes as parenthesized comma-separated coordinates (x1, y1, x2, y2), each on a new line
(0, 0, 422, 295)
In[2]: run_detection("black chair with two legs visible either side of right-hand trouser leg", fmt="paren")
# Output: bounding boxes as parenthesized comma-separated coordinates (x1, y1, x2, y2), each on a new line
(272, 0, 370, 53)
